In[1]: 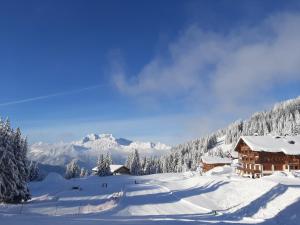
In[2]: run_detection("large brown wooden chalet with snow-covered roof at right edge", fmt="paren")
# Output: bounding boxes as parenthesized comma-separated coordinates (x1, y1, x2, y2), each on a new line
(234, 136, 300, 178)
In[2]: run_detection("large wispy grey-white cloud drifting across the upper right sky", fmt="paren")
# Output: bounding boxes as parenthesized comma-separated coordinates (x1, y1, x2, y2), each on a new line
(114, 14, 300, 114)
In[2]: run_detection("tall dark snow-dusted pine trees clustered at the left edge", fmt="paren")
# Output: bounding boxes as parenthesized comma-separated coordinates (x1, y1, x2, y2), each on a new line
(0, 119, 30, 203)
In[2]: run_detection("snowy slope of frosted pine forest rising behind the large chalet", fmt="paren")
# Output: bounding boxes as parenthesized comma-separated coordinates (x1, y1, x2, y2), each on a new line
(164, 97, 300, 172)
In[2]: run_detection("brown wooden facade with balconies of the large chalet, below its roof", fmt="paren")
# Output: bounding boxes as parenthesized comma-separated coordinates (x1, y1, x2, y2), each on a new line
(235, 138, 300, 178)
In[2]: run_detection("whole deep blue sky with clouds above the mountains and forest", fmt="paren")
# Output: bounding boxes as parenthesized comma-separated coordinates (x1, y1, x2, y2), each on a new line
(0, 0, 300, 144)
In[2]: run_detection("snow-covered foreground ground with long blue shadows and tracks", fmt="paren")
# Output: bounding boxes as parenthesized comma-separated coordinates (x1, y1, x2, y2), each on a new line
(0, 170, 300, 225)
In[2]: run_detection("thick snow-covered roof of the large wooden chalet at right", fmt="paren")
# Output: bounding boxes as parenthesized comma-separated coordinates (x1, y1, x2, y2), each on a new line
(234, 135, 300, 155)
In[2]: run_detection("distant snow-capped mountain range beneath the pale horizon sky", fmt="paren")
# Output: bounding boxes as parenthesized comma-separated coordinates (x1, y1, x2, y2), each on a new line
(28, 134, 171, 169)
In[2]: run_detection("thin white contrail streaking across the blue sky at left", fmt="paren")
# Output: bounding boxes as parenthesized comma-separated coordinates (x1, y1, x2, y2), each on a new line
(0, 85, 105, 107)
